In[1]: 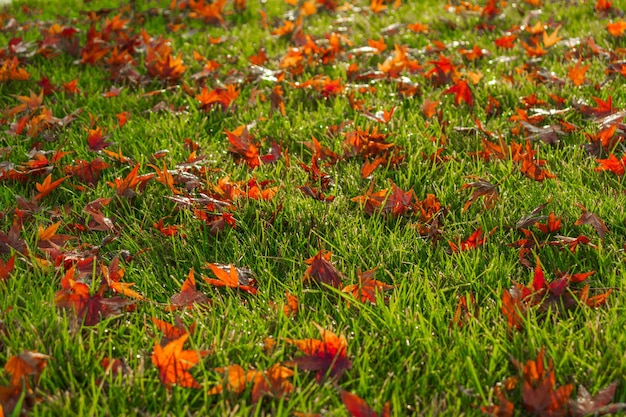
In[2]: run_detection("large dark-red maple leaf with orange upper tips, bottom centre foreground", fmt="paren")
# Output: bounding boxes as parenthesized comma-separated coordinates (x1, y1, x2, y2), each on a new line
(286, 322, 352, 383)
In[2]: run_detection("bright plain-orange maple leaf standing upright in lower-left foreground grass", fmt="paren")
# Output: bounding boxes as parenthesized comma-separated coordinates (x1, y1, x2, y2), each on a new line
(152, 333, 210, 388)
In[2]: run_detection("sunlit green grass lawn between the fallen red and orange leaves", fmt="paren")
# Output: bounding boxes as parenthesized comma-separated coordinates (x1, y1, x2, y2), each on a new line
(0, 0, 626, 416)
